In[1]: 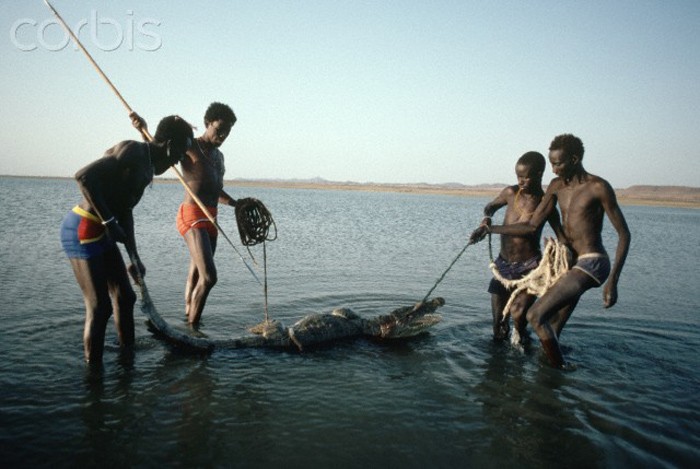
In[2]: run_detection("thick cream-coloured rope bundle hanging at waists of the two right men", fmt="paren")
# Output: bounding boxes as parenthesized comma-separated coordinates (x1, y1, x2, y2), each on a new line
(489, 233, 569, 321)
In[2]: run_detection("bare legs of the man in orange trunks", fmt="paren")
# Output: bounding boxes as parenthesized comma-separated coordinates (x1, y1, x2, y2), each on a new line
(185, 229, 217, 326)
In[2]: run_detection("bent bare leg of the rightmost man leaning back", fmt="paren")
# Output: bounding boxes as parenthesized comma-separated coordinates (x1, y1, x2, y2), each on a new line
(527, 269, 594, 368)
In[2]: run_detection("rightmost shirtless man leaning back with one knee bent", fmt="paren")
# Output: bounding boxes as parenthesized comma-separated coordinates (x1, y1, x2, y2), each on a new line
(490, 134, 631, 368)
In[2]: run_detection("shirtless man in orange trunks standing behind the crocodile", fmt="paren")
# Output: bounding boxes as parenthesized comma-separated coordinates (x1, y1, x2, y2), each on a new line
(177, 103, 236, 326)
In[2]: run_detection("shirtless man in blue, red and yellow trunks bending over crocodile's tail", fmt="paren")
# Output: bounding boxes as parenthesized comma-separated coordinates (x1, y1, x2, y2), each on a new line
(61, 116, 194, 365)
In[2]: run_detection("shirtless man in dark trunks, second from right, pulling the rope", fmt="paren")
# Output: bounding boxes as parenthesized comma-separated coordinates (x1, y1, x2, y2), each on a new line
(470, 151, 562, 340)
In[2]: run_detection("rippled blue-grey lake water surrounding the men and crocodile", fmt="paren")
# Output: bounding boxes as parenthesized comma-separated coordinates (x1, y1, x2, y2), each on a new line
(0, 178, 700, 468)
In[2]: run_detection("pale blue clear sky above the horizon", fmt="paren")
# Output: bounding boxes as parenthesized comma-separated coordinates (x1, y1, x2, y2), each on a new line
(0, 0, 700, 188)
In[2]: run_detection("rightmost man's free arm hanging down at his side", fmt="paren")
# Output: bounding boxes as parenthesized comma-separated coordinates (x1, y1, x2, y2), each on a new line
(600, 182, 632, 308)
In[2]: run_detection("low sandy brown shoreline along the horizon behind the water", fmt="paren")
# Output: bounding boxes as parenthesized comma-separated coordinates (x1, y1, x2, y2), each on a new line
(1, 176, 700, 208)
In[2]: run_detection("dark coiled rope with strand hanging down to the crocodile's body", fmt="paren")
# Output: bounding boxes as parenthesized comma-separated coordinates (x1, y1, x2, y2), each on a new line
(234, 197, 277, 323)
